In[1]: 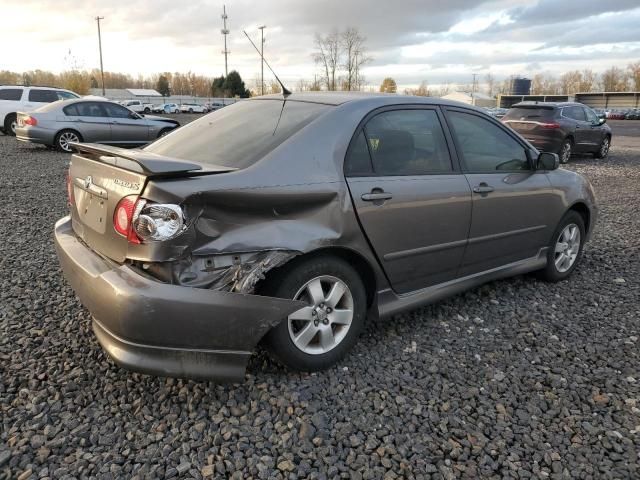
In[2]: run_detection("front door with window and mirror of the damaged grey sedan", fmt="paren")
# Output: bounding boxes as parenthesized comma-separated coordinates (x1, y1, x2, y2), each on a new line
(447, 107, 560, 276)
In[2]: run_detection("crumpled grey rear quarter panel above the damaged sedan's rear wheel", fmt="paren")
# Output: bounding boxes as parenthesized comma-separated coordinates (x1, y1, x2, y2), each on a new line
(128, 99, 386, 288)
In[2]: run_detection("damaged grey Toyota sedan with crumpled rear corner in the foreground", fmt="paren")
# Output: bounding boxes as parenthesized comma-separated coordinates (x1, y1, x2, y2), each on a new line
(55, 93, 597, 381)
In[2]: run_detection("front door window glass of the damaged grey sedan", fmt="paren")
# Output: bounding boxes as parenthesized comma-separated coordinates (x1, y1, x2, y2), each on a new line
(448, 111, 531, 173)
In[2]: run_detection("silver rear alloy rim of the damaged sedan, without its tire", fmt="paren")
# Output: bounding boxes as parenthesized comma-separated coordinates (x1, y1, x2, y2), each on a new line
(287, 275, 354, 355)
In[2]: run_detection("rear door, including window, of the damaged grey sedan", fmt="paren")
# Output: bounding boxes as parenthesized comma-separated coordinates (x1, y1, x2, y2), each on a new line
(345, 106, 471, 293)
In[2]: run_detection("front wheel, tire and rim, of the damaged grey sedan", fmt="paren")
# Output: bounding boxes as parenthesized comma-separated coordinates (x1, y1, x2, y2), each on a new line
(540, 210, 586, 283)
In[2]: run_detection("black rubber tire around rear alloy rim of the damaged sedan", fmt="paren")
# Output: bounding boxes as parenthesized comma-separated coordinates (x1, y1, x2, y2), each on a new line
(263, 256, 367, 371)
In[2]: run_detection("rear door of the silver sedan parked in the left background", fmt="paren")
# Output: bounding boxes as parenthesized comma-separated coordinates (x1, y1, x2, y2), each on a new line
(61, 102, 111, 143)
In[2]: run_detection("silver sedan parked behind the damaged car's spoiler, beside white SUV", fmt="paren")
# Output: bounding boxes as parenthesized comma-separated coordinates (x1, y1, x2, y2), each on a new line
(16, 99, 180, 152)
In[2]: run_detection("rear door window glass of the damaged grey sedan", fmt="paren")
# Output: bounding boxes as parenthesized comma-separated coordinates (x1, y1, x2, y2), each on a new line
(364, 109, 453, 175)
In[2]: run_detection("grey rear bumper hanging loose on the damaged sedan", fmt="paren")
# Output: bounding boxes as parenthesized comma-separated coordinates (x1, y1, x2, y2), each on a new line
(55, 217, 304, 382)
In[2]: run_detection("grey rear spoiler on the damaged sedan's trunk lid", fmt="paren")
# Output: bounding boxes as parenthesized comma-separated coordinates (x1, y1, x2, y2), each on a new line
(69, 142, 237, 176)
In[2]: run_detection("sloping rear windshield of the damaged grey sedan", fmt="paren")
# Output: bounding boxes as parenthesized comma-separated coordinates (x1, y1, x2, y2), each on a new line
(145, 100, 331, 169)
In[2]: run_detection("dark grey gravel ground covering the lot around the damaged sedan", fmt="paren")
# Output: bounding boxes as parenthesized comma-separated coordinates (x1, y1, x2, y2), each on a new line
(0, 128, 640, 480)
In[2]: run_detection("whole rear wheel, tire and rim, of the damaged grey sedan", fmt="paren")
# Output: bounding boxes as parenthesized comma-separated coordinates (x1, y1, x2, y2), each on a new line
(262, 256, 367, 372)
